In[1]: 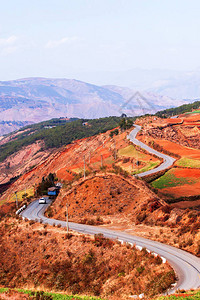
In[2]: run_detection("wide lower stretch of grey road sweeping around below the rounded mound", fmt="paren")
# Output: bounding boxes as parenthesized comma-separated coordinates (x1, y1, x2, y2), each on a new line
(21, 200, 200, 293)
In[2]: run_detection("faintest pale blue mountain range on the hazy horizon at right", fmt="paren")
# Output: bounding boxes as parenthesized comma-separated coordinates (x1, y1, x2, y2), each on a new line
(77, 68, 200, 100)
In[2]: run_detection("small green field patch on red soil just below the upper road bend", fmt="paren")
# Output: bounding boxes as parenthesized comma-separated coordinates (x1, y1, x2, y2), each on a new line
(152, 169, 197, 189)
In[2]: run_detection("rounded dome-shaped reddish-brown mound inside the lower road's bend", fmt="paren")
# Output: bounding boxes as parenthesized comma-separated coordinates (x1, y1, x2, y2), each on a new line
(47, 174, 161, 222)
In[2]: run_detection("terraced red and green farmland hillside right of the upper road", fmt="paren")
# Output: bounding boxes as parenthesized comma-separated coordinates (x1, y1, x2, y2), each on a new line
(134, 110, 200, 202)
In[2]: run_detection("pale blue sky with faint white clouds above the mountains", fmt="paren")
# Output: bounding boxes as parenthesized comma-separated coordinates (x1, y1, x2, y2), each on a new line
(0, 0, 200, 80)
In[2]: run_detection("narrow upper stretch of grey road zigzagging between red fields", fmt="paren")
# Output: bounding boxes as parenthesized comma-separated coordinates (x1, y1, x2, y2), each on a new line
(127, 124, 176, 177)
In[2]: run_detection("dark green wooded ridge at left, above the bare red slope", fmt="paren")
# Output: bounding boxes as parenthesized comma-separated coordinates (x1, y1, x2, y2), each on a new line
(0, 117, 120, 161)
